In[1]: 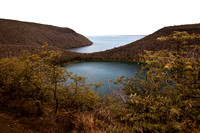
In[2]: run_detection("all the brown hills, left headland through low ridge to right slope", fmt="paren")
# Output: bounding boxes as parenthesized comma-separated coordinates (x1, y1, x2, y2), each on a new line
(0, 19, 200, 63)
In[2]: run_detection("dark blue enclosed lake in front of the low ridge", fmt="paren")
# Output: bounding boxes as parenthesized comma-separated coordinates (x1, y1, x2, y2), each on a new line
(64, 62, 141, 94)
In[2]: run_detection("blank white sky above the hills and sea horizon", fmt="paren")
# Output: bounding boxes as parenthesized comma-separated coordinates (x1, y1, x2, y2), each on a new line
(0, 0, 200, 35)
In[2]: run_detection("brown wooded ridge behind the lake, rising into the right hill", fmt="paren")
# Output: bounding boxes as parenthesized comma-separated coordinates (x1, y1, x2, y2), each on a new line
(52, 24, 200, 63)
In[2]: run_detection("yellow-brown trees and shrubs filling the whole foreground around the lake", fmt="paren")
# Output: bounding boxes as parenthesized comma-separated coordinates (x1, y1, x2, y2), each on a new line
(0, 31, 200, 133)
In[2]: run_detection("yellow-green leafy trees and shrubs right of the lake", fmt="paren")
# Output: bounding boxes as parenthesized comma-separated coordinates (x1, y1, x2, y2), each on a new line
(108, 31, 200, 132)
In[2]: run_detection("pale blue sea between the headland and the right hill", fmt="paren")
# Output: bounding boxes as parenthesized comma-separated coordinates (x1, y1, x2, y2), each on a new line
(68, 35, 145, 53)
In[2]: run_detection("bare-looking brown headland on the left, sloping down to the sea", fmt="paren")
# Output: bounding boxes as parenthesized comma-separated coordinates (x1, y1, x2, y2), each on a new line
(0, 19, 92, 49)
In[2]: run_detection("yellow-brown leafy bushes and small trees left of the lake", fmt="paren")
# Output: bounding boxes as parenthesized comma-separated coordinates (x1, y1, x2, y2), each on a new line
(0, 44, 99, 116)
